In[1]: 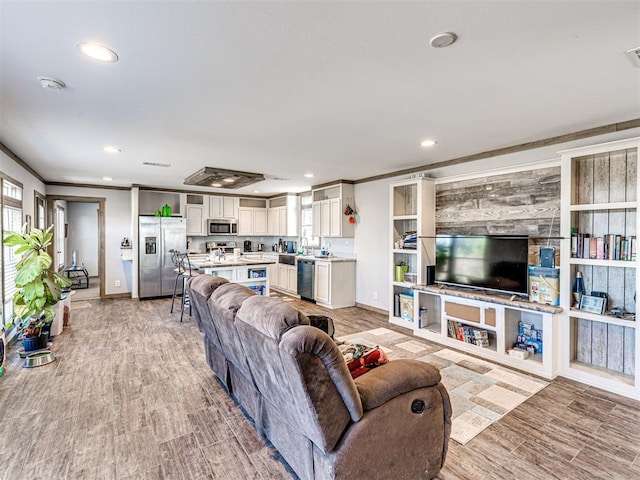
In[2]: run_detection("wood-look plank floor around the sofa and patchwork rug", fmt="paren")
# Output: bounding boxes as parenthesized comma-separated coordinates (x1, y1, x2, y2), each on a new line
(0, 299, 640, 480)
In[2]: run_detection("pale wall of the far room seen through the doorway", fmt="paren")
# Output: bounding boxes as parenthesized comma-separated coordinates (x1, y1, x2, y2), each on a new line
(66, 202, 99, 277)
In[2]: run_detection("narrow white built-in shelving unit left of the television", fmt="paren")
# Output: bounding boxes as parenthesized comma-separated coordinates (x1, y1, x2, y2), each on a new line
(389, 177, 436, 329)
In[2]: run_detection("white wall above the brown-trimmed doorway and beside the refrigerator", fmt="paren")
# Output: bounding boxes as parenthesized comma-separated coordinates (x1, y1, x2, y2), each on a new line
(46, 186, 133, 295)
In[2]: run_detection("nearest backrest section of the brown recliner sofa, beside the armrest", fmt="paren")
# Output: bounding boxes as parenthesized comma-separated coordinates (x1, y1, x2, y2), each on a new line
(236, 296, 363, 452)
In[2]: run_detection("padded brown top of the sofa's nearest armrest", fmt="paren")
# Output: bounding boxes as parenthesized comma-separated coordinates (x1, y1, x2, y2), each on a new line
(354, 359, 440, 412)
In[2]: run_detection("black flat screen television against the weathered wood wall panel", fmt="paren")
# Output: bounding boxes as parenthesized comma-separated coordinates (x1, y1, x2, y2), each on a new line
(435, 235, 529, 295)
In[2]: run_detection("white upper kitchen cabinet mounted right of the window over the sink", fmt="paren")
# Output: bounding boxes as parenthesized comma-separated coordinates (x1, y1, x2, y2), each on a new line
(312, 183, 355, 237)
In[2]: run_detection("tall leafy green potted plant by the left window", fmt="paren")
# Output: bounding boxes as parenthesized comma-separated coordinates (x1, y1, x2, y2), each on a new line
(4, 224, 71, 351)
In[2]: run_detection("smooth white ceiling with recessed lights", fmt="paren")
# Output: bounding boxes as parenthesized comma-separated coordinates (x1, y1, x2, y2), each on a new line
(0, 0, 640, 194)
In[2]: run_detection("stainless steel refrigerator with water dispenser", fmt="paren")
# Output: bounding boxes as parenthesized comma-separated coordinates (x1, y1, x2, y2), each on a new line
(138, 216, 187, 298)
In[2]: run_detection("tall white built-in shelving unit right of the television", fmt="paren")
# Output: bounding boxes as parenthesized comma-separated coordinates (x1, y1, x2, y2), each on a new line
(560, 138, 640, 398)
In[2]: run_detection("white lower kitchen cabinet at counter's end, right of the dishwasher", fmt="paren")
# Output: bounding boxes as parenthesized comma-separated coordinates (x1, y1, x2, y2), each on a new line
(313, 260, 356, 309)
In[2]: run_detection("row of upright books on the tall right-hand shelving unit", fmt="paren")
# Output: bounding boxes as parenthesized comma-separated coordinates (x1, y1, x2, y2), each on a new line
(571, 232, 637, 261)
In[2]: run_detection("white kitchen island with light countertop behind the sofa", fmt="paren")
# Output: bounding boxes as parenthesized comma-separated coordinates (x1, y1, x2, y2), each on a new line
(189, 255, 276, 295)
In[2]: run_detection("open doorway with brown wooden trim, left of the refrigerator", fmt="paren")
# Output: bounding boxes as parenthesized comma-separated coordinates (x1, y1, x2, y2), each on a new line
(47, 195, 105, 300)
